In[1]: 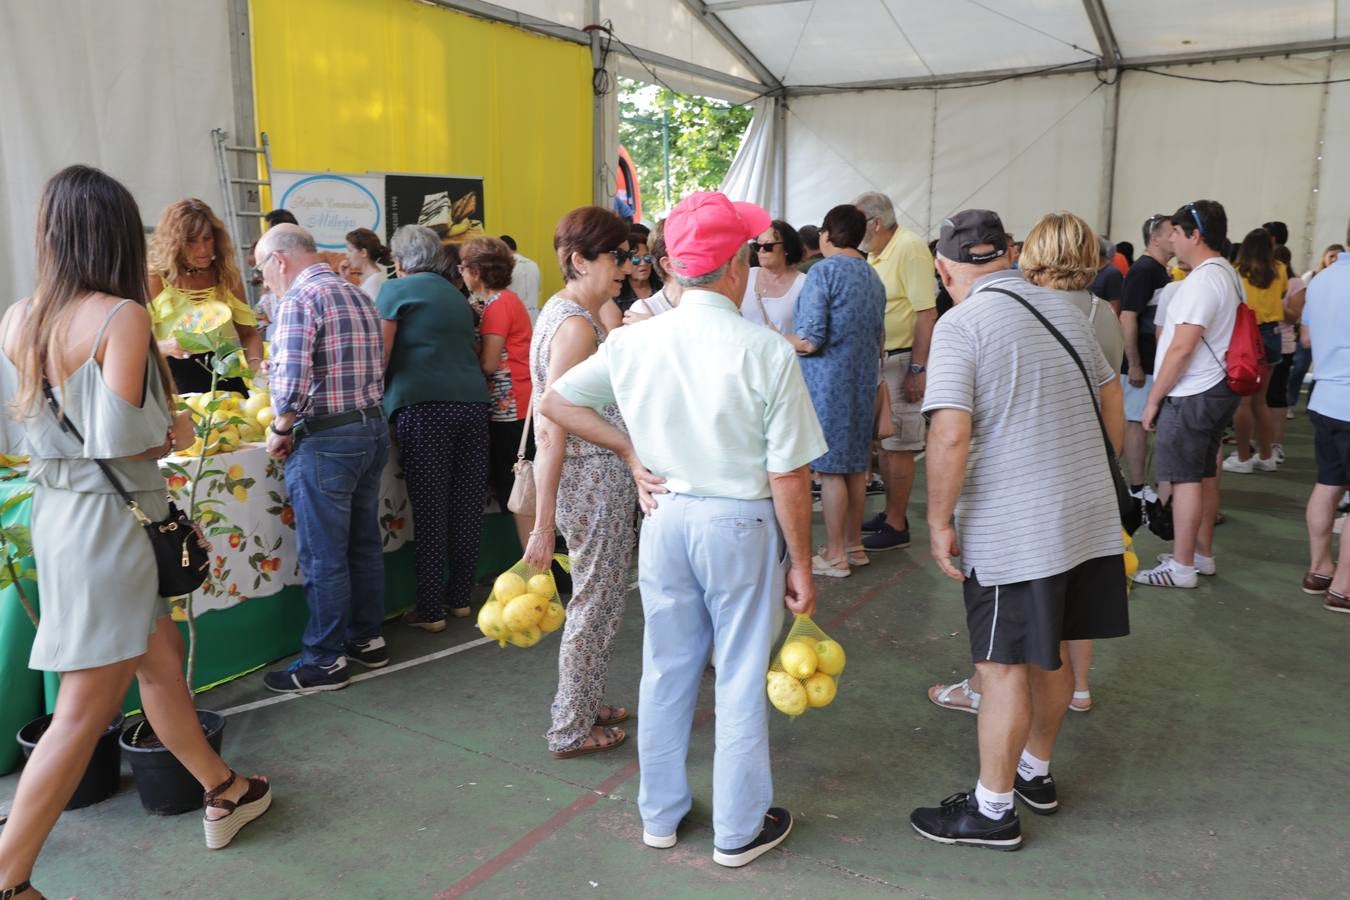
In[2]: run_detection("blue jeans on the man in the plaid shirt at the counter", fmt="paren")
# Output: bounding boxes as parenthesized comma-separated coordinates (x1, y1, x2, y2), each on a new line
(286, 418, 389, 665)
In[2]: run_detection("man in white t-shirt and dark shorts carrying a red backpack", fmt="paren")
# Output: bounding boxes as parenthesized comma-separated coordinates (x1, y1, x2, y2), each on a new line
(1134, 200, 1242, 587)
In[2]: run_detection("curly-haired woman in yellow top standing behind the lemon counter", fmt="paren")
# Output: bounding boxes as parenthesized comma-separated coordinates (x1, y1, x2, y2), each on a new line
(147, 198, 262, 394)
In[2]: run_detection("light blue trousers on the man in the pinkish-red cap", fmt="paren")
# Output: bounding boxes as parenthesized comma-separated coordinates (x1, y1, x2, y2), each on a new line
(637, 495, 786, 850)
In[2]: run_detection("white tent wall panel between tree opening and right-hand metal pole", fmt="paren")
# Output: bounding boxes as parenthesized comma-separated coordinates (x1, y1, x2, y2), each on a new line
(787, 74, 1107, 237)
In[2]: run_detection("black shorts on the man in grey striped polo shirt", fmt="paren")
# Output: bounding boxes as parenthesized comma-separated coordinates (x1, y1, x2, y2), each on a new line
(965, 555, 1130, 669)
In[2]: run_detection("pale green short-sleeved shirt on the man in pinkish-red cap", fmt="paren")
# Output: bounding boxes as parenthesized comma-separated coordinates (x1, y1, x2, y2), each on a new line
(554, 290, 828, 499)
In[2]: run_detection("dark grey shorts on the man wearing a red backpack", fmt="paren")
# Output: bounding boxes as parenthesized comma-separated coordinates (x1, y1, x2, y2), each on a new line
(1153, 381, 1239, 484)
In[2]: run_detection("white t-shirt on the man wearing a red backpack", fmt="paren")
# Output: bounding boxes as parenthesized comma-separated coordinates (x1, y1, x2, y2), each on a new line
(1153, 256, 1242, 397)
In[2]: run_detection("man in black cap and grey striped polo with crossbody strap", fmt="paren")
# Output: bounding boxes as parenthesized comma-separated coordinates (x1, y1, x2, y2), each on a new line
(910, 209, 1130, 850)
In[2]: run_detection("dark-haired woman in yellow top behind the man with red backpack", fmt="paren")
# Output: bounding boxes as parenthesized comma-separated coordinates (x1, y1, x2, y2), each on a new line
(1223, 228, 1289, 475)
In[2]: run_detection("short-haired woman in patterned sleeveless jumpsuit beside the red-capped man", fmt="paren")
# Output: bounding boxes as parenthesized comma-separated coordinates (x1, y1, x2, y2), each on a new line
(525, 206, 637, 758)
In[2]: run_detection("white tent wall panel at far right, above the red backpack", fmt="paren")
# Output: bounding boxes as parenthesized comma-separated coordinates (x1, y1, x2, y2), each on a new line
(1110, 54, 1333, 266)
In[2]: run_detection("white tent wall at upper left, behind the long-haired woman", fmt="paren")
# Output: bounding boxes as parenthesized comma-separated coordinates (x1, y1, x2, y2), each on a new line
(0, 0, 235, 306)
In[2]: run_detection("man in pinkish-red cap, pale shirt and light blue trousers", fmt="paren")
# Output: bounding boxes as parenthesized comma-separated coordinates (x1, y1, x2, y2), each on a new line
(540, 193, 826, 866)
